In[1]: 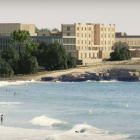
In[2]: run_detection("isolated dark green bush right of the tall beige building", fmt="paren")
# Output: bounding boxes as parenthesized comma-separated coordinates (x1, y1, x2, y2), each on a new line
(110, 47, 131, 61)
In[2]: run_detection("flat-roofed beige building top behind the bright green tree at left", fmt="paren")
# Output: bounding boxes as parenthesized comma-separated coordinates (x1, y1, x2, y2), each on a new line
(0, 23, 37, 36)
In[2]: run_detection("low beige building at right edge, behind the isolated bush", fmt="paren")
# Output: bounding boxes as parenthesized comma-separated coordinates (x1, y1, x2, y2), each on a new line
(113, 32, 140, 58)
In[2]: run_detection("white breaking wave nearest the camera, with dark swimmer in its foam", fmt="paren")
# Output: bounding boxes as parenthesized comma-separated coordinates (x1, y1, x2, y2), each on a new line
(46, 124, 129, 140)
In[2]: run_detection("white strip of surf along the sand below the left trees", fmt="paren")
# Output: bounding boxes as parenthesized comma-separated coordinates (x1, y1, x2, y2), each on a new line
(0, 79, 36, 86)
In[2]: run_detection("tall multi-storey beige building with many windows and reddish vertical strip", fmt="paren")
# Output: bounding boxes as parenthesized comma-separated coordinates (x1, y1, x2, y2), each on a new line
(61, 23, 115, 60)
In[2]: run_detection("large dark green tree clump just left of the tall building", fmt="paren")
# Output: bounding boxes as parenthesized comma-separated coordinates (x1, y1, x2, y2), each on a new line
(31, 42, 76, 71)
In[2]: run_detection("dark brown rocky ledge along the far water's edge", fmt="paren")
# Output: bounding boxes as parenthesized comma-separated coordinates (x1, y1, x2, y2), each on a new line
(42, 69, 140, 82)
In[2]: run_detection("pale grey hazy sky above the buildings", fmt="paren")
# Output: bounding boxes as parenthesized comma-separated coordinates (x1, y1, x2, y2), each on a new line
(0, 0, 140, 35)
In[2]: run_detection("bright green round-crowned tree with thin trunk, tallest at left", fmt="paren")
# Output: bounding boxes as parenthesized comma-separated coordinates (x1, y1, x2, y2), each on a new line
(8, 30, 31, 54)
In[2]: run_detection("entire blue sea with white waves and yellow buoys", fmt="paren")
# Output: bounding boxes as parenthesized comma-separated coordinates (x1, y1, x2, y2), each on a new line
(0, 80, 140, 140)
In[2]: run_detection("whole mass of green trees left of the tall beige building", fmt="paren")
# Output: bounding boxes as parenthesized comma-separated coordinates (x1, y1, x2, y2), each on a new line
(0, 28, 76, 74)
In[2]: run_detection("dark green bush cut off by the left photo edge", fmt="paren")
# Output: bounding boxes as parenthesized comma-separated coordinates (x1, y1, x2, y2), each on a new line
(0, 57, 14, 75)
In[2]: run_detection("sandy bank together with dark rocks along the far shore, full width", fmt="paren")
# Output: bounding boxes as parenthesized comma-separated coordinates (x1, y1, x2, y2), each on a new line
(0, 65, 140, 82)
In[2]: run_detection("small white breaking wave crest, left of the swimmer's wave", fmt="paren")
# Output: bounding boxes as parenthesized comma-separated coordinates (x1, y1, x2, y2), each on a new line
(30, 115, 66, 126)
